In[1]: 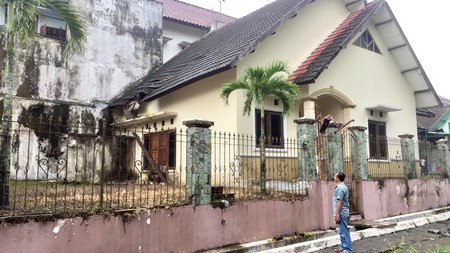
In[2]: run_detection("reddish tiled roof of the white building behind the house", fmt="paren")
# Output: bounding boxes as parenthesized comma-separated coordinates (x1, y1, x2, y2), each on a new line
(157, 0, 236, 28)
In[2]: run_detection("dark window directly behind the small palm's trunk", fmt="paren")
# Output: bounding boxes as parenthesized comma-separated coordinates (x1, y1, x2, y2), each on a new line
(255, 110, 284, 148)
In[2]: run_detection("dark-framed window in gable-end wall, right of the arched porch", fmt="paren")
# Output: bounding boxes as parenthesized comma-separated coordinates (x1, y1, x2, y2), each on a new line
(369, 120, 388, 160)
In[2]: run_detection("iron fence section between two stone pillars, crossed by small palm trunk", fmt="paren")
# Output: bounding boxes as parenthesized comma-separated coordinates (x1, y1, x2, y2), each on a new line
(211, 132, 308, 199)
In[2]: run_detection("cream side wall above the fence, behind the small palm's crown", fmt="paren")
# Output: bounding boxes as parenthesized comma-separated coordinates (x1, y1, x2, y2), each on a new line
(233, 0, 349, 137)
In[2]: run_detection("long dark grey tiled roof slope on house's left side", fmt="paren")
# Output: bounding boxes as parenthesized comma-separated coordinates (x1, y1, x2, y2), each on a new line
(109, 0, 312, 107)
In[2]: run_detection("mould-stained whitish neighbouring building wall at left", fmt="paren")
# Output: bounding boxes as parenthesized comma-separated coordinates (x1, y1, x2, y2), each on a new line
(0, 0, 162, 182)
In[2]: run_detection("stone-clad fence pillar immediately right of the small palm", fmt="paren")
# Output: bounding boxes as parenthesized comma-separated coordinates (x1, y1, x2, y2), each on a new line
(294, 118, 317, 181)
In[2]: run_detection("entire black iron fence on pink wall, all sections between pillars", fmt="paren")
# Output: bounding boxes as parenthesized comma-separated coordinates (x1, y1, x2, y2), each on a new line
(0, 114, 444, 216)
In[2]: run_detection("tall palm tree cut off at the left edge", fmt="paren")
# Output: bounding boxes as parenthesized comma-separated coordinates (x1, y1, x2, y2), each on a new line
(0, 0, 87, 208)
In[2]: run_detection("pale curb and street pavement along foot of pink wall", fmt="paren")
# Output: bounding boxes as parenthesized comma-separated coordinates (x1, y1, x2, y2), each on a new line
(204, 206, 450, 253)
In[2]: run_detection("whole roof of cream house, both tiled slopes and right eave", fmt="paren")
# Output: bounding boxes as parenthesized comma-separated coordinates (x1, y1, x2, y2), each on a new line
(110, 0, 441, 108)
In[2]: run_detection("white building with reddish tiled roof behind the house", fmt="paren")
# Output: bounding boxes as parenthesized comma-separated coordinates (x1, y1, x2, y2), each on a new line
(157, 0, 235, 63)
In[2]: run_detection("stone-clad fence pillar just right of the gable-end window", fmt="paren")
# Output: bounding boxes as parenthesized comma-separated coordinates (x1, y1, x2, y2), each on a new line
(398, 134, 417, 179)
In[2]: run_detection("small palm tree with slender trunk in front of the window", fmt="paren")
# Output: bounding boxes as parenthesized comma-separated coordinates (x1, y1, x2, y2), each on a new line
(220, 61, 300, 193)
